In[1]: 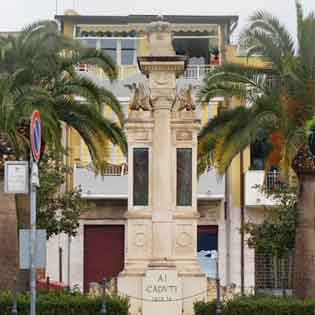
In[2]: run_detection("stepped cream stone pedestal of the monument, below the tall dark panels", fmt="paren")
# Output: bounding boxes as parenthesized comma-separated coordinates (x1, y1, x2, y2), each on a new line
(118, 211, 207, 315)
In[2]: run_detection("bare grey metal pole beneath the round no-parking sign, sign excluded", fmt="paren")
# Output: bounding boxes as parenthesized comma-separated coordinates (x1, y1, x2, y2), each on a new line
(30, 157, 38, 315)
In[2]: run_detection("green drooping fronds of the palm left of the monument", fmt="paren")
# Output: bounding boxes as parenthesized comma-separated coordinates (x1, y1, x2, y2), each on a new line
(0, 21, 126, 160)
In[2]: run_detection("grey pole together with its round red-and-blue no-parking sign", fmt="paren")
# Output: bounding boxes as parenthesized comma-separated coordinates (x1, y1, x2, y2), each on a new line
(30, 111, 42, 315)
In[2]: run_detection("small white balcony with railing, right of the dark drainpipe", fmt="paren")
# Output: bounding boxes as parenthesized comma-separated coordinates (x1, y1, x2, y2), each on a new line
(245, 171, 281, 207)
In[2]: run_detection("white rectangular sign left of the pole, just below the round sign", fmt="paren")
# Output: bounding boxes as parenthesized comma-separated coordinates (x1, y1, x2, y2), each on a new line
(4, 161, 29, 194)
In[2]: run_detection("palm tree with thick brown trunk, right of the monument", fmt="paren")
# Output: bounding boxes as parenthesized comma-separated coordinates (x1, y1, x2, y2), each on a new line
(199, 1, 315, 298)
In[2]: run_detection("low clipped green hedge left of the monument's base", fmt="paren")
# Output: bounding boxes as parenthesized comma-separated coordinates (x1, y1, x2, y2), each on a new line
(0, 292, 129, 315)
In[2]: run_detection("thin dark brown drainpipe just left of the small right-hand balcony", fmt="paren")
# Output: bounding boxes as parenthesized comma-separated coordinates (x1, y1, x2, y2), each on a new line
(240, 151, 245, 295)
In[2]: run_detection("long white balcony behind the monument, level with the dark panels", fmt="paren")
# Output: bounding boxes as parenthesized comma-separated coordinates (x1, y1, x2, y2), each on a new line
(73, 164, 225, 200)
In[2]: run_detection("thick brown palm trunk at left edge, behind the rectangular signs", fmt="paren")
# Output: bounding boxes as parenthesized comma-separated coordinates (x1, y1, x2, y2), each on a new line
(0, 174, 19, 291)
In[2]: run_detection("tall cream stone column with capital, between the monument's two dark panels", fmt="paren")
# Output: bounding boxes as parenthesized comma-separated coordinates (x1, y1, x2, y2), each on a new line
(150, 78, 175, 264)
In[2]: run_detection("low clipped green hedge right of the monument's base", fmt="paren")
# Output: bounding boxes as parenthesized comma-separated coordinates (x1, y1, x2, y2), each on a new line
(194, 296, 315, 315)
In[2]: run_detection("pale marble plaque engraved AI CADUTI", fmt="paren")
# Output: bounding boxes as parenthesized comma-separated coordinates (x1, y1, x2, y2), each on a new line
(142, 269, 182, 315)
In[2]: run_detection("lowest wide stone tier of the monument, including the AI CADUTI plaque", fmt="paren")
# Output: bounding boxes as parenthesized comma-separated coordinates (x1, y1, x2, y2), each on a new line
(118, 265, 207, 315)
